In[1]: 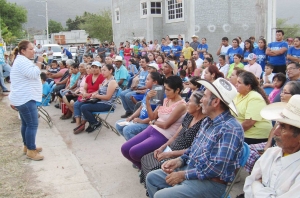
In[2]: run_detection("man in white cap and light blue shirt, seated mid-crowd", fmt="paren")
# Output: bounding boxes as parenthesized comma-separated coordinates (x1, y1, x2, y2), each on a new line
(115, 56, 129, 88)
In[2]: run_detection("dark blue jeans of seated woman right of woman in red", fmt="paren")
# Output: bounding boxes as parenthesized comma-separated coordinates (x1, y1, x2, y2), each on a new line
(80, 103, 111, 124)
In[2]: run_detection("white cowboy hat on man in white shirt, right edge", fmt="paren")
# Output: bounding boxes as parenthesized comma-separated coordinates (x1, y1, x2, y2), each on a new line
(260, 95, 300, 128)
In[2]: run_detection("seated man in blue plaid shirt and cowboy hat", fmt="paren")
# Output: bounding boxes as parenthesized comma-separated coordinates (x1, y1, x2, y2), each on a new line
(146, 78, 244, 198)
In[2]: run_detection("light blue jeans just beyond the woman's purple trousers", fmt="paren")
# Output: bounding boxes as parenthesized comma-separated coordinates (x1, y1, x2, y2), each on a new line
(116, 119, 149, 140)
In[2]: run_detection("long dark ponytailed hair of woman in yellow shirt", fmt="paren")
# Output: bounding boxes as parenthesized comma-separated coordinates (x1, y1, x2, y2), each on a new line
(238, 71, 270, 104)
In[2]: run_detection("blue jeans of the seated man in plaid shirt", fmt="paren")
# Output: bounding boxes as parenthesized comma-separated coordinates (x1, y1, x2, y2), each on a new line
(146, 166, 226, 198)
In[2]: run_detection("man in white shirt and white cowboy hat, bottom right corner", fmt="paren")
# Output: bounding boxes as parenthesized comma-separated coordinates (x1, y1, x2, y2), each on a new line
(244, 95, 300, 198)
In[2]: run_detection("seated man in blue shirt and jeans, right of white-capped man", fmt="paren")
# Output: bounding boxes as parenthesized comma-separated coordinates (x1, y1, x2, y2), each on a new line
(120, 56, 149, 118)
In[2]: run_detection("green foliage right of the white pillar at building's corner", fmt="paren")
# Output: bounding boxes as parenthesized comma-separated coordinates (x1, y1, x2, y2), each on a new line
(276, 18, 300, 38)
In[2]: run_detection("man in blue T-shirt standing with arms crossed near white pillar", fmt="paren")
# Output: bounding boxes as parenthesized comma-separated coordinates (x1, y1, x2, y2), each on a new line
(266, 30, 288, 74)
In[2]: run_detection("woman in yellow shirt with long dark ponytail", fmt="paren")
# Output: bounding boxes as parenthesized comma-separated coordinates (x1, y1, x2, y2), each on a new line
(233, 71, 272, 144)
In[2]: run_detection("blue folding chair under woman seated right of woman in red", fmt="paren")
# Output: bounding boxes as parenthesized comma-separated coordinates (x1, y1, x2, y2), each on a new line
(93, 87, 122, 140)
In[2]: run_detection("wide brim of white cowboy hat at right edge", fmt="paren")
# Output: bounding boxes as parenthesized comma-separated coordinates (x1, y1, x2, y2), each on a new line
(260, 102, 300, 128)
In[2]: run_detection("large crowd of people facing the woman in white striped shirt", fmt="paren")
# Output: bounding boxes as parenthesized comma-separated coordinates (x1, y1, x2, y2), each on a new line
(17, 30, 300, 198)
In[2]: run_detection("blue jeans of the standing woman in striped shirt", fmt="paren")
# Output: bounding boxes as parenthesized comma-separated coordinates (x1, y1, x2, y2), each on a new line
(16, 100, 39, 150)
